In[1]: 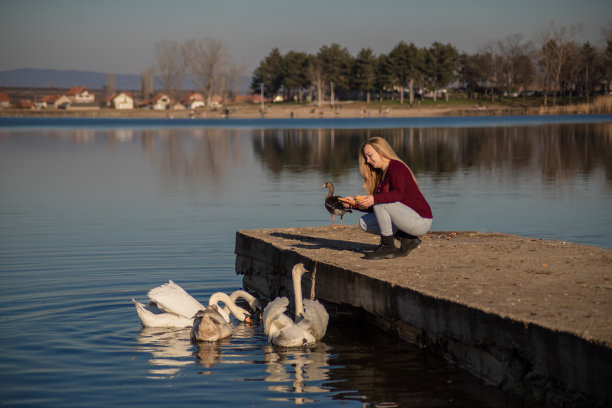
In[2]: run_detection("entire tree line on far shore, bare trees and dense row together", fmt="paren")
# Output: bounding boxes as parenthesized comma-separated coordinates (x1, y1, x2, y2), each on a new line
(146, 22, 612, 106)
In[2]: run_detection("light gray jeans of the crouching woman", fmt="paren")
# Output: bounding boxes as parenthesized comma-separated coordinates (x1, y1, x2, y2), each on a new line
(359, 202, 433, 237)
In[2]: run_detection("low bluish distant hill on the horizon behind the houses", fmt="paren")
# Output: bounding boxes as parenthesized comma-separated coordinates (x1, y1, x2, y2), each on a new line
(0, 68, 250, 93)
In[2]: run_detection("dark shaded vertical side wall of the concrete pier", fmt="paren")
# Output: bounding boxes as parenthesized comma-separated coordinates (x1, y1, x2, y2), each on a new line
(235, 231, 612, 406)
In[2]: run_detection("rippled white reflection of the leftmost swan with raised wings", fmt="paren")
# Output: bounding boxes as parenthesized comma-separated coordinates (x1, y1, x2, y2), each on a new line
(136, 327, 193, 378)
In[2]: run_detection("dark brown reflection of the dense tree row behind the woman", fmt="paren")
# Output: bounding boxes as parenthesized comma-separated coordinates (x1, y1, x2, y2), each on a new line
(253, 123, 612, 180)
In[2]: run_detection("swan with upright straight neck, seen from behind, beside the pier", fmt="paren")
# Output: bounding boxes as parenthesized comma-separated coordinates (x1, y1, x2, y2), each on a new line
(263, 263, 329, 347)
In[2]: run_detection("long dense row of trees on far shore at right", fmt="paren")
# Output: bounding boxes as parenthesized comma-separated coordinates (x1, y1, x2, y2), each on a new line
(251, 23, 612, 105)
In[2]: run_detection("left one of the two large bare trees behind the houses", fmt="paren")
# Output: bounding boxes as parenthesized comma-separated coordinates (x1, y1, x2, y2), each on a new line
(154, 40, 186, 105)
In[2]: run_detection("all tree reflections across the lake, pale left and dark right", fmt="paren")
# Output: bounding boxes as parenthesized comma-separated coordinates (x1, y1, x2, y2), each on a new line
(26, 123, 612, 185)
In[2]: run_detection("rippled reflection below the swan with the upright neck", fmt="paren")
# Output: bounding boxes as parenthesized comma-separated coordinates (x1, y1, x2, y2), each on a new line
(264, 343, 330, 405)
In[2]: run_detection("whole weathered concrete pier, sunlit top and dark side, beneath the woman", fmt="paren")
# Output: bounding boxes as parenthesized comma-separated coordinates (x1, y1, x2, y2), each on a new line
(236, 226, 612, 406)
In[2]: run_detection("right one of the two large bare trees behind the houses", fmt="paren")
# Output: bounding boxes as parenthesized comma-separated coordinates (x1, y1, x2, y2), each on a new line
(185, 37, 229, 106)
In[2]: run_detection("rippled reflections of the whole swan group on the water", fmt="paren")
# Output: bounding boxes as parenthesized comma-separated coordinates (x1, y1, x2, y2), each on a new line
(137, 308, 331, 405)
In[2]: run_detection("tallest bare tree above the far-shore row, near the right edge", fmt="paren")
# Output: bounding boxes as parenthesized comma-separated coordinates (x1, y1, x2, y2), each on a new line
(540, 22, 581, 106)
